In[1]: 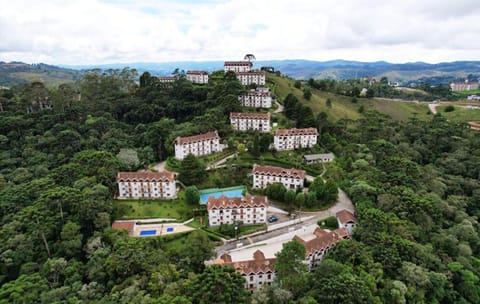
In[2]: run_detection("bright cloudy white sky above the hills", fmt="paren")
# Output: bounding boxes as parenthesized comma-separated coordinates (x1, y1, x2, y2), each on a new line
(0, 0, 480, 64)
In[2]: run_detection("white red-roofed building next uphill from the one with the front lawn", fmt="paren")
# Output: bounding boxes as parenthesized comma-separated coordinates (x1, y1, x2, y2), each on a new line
(175, 131, 222, 160)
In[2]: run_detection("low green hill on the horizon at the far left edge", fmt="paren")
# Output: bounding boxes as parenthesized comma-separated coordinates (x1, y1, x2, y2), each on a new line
(0, 61, 82, 87)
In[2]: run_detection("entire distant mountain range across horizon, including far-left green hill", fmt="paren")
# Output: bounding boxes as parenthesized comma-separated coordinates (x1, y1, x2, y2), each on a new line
(0, 59, 480, 86)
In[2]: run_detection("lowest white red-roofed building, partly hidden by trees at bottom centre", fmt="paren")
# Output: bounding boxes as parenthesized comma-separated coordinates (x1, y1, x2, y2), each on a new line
(213, 250, 277, 291)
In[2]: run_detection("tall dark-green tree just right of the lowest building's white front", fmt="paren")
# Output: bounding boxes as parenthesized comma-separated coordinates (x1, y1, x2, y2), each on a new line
(274, 240, 308, 297)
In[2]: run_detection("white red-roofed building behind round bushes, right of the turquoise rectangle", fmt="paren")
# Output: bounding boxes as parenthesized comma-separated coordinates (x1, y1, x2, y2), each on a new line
(252, 164, 305, 190)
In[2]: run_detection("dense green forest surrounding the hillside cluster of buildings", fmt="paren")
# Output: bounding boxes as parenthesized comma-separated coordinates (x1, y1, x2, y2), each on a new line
(0, 69, 480, 304)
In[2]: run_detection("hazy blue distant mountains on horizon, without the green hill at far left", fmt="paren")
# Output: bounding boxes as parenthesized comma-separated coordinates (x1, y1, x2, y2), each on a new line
(64, 59, 480, 84)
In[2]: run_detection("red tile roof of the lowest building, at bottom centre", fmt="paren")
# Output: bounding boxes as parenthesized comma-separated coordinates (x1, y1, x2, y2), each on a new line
(215, 250, 277, 275)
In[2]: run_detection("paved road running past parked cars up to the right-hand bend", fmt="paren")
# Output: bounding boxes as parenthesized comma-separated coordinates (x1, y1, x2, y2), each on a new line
(215, 189, 355, 256)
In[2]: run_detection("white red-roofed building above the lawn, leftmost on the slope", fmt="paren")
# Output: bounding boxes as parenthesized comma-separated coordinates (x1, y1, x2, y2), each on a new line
(117, 171, 177, 199)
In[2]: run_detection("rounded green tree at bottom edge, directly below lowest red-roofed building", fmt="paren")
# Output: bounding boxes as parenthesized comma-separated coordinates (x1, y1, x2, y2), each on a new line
(191, 265, 248, 304)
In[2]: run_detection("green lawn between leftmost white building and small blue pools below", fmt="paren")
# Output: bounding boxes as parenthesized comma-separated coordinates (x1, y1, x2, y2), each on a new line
(113, 192, 198, 221)
